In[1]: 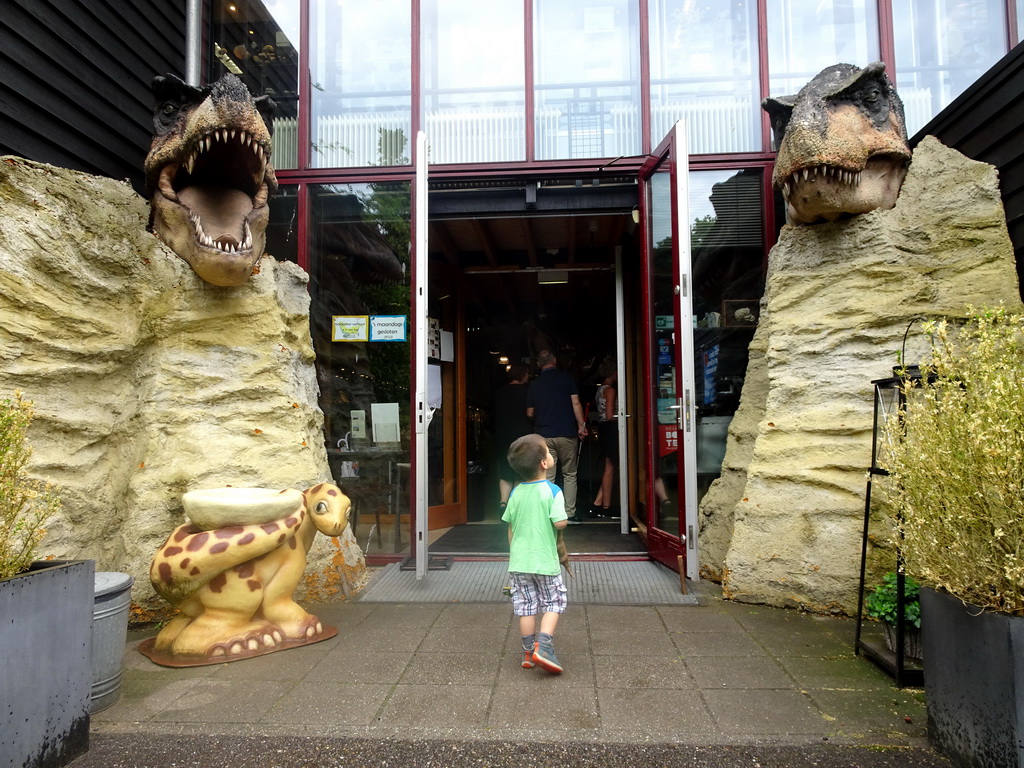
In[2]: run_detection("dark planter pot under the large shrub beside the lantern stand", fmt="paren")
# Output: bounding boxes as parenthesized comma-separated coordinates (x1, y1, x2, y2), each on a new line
(921, 589, 1024, 768)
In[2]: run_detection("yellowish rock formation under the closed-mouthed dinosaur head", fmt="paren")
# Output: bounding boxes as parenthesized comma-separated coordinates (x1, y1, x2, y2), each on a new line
(699, 137, 1020, 613)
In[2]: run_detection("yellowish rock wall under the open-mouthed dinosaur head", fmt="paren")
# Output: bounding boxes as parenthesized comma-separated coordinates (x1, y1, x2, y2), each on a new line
(0, 157, 367, 621)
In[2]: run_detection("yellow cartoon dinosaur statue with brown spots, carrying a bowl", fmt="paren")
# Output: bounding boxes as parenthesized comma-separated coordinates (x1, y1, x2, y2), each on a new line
(139, 483, 351, 667)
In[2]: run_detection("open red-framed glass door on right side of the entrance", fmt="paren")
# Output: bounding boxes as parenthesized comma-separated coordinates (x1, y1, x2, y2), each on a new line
(640, 121, 697, 579)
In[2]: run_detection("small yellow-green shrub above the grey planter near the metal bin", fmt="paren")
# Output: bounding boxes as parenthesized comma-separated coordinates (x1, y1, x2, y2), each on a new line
(0, 392, 60, 579)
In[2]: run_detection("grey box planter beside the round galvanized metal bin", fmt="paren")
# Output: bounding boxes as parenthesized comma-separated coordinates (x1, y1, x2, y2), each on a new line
(0, 560, 95, 768)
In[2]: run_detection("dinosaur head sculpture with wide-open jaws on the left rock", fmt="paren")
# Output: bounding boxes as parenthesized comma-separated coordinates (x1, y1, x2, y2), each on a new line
(145, 75, 278, 286)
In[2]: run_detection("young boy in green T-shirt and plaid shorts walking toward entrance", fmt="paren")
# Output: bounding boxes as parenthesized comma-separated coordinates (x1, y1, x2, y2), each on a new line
(502, 434, 567, 675)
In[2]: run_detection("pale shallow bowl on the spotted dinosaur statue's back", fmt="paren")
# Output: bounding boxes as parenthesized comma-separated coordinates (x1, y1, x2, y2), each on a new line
(181, 487, 303, 530)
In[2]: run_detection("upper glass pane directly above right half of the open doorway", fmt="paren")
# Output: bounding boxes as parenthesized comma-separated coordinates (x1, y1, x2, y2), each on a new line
(534, 0, 641, 160)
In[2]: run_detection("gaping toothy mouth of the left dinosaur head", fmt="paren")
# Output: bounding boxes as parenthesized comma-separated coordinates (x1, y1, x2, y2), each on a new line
(153, 128, 269, 255)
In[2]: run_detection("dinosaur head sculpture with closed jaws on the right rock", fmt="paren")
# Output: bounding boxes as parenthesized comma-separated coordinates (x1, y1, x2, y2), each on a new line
(761, 61, 910, 224)
